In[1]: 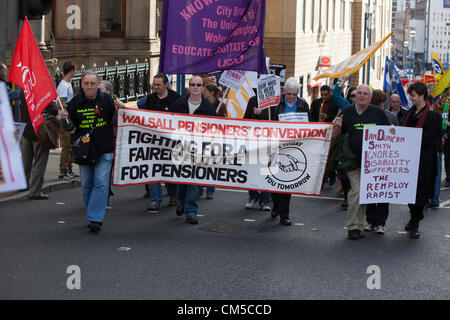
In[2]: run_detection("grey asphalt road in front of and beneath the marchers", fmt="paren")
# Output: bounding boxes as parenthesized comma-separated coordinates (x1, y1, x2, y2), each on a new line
(0, 152, 450, 300)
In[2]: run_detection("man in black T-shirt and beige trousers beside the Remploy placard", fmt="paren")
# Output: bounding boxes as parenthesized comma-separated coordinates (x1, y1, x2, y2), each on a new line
(336, 85, 389, 240)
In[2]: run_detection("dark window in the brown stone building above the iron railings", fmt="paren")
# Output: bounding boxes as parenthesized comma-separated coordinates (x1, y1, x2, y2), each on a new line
(100, 0, 126, 37)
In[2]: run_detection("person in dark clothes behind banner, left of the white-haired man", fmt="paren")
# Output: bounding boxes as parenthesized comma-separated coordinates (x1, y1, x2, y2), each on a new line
(244, 89, 275, 211)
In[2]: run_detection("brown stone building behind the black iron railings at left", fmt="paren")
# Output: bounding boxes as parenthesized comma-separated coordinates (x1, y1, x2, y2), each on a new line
(4, 0, 163, 73)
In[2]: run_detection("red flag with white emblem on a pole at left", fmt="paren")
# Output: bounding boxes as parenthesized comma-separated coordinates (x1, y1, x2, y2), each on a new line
(8, 18, 58, 133)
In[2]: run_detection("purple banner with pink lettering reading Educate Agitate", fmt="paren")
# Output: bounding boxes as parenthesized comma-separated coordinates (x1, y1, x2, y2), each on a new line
(159, 0, 268, 74)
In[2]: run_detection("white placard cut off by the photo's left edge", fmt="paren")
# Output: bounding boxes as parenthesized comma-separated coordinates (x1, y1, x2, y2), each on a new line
(0, 83, 27, 192)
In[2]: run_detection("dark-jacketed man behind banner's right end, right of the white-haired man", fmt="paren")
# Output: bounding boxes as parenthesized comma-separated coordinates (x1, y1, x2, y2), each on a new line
(309, 85, 339, 122)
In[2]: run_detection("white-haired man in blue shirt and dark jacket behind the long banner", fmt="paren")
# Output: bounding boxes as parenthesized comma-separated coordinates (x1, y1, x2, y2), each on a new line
(270, 77, 310, 226)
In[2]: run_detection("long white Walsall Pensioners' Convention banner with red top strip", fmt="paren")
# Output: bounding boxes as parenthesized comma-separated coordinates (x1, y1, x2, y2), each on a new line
(113, 109, 332, 196)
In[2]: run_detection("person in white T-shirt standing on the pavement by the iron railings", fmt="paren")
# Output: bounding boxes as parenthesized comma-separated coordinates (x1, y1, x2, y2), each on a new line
(56, 62, 78, 181)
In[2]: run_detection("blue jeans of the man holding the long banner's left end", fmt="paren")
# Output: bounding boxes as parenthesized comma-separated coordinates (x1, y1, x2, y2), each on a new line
(80, 153, 114, 222)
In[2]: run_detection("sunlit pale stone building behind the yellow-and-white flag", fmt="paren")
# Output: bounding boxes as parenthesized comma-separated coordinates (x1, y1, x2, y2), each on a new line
(264, 0, 392, 102)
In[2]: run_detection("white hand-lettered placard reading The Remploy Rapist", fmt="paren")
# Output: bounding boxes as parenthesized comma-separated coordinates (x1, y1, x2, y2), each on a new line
(359, 126, 422, 204)
